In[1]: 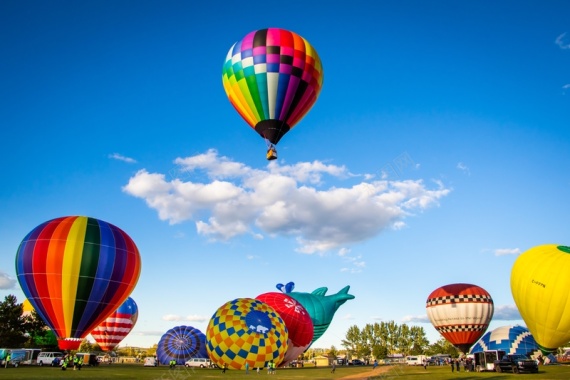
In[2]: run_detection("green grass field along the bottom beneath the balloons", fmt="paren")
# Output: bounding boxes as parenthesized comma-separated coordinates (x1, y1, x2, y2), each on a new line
(0, 364, 570, 380)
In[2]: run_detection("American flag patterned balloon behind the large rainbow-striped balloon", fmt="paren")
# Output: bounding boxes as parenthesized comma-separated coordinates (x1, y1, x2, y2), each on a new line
(91, 297, 139, 351)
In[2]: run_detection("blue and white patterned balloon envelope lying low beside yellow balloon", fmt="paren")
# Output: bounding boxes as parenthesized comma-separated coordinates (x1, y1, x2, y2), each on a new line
(469, 326, 538, 356)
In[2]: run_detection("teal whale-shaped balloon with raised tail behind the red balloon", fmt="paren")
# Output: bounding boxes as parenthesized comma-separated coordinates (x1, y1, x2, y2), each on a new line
(287, 286, 354, 344)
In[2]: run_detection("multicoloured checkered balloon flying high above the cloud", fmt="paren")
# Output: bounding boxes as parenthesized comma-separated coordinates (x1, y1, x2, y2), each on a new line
(222, 28, 323, 160)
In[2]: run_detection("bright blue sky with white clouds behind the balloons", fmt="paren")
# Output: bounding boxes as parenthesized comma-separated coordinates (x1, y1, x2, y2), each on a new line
(0, 0, 570, 348)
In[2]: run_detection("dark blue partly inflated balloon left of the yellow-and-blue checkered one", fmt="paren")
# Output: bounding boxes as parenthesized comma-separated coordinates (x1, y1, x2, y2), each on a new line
(156, 326, 208, 365)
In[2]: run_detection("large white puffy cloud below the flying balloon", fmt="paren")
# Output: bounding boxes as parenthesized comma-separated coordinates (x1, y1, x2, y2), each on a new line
(123, 149, 451, 254)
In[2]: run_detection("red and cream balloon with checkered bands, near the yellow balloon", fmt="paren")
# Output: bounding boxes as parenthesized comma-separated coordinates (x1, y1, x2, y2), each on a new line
(426, 284, 494, 353)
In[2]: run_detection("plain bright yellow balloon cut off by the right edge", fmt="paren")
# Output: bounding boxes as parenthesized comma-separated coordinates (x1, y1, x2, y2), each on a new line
(511, 244, 570, 354)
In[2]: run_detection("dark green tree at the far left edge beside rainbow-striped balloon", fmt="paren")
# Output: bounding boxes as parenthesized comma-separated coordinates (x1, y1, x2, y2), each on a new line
(0, 294, 29, 347)
